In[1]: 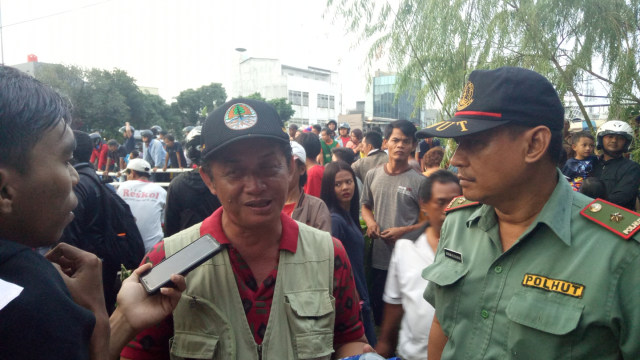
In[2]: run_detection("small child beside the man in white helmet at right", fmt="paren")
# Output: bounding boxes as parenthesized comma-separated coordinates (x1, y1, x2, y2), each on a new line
(562, 131, 596, 191)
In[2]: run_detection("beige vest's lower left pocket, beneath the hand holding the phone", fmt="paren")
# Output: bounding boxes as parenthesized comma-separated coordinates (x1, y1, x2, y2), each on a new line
(170, 331, 218, 360)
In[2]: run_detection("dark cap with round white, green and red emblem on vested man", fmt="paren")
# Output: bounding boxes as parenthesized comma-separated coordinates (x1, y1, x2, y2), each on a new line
(201, 98, 289, 159)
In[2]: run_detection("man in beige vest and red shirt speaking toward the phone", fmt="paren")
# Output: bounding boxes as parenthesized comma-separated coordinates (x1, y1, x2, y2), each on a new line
(122, 99, 372, 360)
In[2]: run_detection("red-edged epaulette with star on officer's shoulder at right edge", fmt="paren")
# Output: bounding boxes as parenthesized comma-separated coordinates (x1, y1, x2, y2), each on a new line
(580, 199, 640, 240)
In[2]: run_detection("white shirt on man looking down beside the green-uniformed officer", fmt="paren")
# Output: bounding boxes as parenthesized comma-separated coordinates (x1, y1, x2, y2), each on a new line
(382, 234, 435, 360)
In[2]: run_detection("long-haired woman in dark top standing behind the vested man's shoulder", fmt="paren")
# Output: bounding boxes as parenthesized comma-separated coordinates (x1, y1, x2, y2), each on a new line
(320, 161, 376, 346)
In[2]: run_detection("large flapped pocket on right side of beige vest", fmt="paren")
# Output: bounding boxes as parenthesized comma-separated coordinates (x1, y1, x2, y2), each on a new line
(284, 289, 335, 359)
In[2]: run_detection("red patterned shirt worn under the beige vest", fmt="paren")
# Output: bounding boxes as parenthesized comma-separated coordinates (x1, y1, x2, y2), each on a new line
(120, 208, 364, 360)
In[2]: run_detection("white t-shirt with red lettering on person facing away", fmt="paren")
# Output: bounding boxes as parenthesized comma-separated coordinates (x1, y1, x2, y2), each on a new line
(118, 180, 167, 253)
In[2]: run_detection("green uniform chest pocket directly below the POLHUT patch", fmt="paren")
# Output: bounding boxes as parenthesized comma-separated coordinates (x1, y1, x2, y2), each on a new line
(506, 289, 584, 359)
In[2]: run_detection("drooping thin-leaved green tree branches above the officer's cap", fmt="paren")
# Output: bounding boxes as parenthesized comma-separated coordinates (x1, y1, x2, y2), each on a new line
(327, 0, 640, 124)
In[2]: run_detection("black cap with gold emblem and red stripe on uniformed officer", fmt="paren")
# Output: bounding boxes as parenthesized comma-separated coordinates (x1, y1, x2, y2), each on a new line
(416, 67, 564, 138)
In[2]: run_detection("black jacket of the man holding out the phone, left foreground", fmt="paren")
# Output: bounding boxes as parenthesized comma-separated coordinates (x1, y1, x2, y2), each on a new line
(0, 239, 95, 360)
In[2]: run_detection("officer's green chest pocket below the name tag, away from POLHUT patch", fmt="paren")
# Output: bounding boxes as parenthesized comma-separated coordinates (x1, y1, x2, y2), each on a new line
(422, 256, 469, 334)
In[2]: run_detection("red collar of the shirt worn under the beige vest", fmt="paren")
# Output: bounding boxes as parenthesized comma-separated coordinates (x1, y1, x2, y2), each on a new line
(200, 207, 298, 254)
